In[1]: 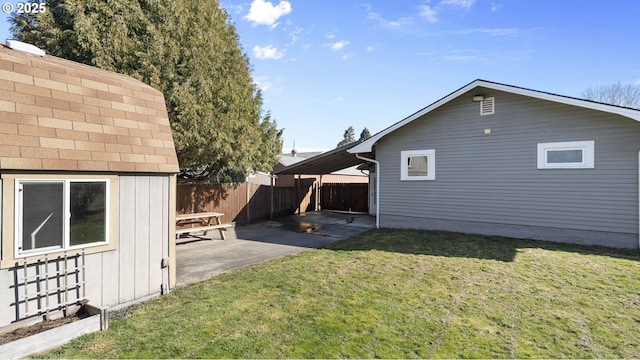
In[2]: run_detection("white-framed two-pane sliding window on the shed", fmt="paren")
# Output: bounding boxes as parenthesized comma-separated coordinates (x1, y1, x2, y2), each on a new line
(16, 179, 109, 256)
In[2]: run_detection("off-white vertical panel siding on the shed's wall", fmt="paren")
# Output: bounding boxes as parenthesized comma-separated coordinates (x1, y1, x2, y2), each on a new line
(0, 175, 173, 327)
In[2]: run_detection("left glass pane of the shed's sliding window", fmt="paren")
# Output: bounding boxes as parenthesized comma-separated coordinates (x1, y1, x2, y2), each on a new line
(22, 183, 64, 250)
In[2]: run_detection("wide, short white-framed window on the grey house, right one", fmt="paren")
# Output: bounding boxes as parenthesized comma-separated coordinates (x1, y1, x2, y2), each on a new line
(538, 141, 595, 169)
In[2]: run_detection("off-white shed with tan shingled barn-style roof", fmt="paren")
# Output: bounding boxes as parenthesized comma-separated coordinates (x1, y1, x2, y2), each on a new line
(0, 41, 179, 327)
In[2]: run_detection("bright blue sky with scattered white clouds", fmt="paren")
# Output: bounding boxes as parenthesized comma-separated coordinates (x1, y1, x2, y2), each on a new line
(0, 0, 640, 151)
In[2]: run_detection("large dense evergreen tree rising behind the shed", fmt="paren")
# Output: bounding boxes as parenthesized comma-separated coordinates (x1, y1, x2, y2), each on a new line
(11, 0, 282, 179)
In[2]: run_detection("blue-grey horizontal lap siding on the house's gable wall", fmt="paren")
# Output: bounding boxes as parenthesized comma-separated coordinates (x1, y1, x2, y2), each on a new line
(376, 88, 640, 247)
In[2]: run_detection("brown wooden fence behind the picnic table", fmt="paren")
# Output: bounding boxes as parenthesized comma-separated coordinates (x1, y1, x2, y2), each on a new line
(176, 179, 316, 224)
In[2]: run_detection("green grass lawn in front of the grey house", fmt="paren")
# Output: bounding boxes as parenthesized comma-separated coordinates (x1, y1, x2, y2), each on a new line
(37, 230, 640, 358)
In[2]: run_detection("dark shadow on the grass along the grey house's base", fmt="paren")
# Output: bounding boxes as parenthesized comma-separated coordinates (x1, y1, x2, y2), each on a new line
(325, 229, 640, 262)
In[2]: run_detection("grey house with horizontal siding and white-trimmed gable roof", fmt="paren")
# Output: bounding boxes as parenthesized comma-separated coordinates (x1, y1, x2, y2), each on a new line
(347, 80, 640, 248)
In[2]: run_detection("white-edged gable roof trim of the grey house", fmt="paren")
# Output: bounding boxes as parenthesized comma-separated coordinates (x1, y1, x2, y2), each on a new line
(347, 79, 640, 154)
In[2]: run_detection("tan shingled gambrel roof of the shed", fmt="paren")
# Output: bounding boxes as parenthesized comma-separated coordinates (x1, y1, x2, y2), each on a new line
(0, 46, 179, 173)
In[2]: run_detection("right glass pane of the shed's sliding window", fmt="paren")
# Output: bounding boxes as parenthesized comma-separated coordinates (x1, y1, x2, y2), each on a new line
(69, 182, 107, 246)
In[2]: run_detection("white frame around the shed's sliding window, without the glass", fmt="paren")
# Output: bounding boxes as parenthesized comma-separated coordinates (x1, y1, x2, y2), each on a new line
(14, 178, 111, 258)
